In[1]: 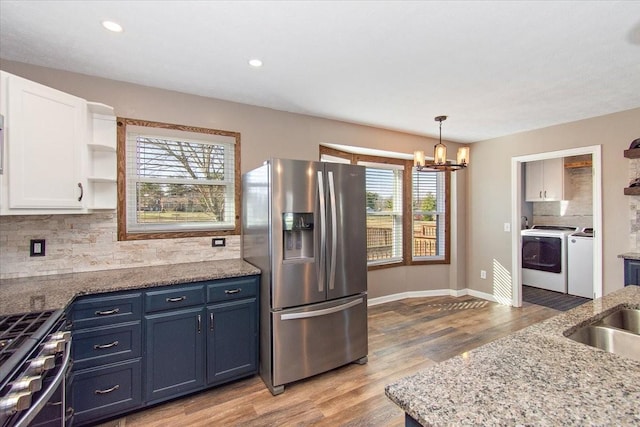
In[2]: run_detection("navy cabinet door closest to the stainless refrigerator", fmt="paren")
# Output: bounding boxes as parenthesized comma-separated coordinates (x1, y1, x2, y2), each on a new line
(207, 298, 258, 385)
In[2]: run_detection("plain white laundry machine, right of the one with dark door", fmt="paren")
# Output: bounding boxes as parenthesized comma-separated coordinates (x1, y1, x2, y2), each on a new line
(567, 228, 593, 299)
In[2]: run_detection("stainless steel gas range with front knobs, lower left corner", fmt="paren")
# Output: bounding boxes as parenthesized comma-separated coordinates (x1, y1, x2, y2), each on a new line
(0, 310, 73, 427)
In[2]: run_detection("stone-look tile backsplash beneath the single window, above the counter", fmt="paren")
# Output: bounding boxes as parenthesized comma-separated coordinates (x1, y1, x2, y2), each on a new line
(0, 212, 240, 279)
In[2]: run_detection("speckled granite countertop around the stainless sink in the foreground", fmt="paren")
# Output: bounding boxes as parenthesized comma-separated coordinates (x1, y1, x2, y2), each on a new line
(385, 286, 640, 426)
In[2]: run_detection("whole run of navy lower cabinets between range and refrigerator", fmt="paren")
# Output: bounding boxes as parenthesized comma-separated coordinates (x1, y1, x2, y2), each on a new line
(68, 276, 259, 427)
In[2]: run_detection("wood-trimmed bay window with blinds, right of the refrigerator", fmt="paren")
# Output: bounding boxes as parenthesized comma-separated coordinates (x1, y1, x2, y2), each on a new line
(320, 146, 451, 269)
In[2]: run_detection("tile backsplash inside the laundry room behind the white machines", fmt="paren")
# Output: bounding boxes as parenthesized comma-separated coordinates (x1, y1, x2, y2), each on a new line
(530, 167, 593, 228)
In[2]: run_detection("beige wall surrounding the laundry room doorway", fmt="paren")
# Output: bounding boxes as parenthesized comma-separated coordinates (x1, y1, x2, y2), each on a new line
(467, 109, 640, 300)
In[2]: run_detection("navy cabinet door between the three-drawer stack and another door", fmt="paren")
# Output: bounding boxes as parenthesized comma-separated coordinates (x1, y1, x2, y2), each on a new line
(145, 307, 205, 403)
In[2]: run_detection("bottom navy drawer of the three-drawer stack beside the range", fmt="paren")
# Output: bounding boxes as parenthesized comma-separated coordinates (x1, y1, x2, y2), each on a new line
(71, 359, 142, 424)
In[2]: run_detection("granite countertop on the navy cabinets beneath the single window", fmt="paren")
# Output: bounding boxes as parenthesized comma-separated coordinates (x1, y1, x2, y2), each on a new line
(0, 259, 260, 315)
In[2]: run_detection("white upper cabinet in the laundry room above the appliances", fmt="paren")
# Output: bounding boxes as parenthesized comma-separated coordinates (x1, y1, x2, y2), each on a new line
(525, 158, 571, 202)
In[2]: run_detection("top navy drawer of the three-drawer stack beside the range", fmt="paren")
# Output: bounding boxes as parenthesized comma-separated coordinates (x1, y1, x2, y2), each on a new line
(69, 292, 142, 330)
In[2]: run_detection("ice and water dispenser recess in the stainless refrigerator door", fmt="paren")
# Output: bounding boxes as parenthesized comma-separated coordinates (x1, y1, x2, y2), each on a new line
(282, 212, 314, 260)
